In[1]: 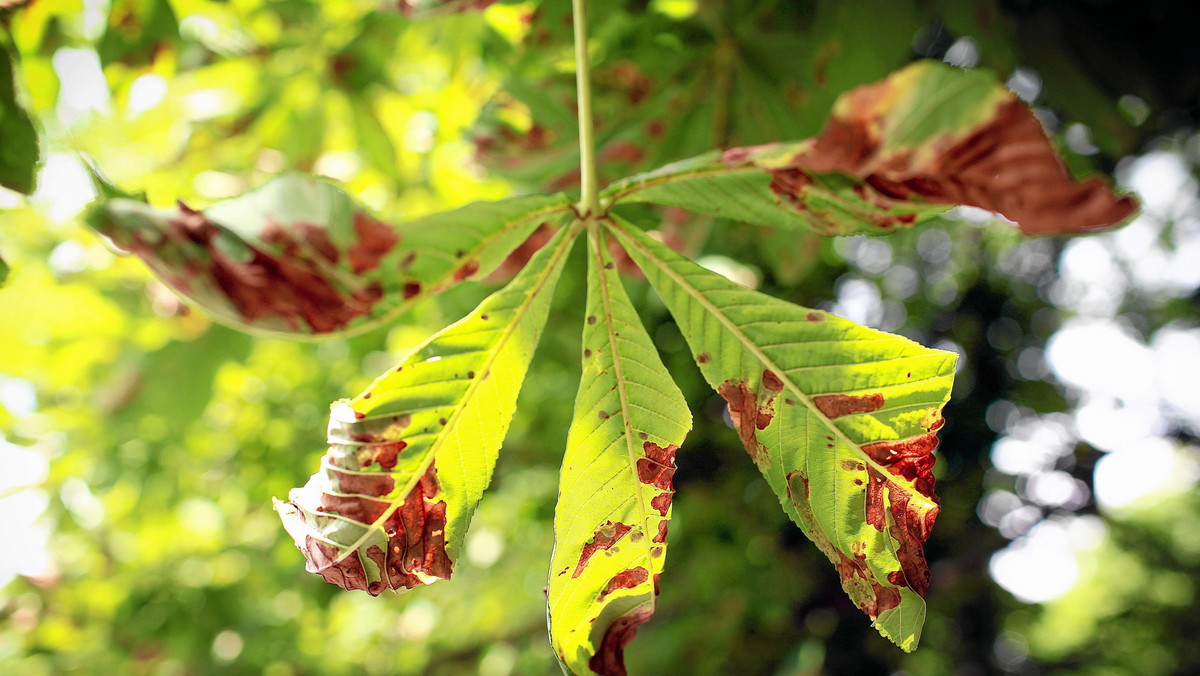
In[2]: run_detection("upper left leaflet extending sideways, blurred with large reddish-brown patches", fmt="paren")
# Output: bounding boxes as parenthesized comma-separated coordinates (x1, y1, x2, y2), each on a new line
(88, 174, 569, 337)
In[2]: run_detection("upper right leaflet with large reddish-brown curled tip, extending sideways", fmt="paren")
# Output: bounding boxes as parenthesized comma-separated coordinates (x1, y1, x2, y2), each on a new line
(604, 61, 1136, 234)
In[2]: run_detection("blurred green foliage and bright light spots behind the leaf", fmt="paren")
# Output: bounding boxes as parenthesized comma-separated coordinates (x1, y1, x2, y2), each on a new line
(0, 0, 1200, 676)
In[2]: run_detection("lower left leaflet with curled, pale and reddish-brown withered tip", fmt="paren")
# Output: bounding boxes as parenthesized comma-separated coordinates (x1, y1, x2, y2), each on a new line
(275, 222, 577, 596)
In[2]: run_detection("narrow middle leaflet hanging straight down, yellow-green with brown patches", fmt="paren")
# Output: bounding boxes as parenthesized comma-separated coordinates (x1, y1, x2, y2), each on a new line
(546, 232, 691, 674)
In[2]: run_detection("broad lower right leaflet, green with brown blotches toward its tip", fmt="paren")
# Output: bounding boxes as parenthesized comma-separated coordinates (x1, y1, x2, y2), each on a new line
(612, 221, 955, 651)
